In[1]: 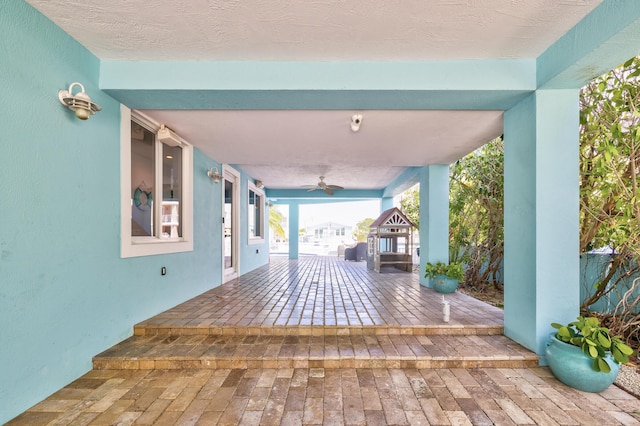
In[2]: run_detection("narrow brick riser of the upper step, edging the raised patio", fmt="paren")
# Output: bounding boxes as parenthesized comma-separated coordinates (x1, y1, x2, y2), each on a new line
(133, 321, 504, 336)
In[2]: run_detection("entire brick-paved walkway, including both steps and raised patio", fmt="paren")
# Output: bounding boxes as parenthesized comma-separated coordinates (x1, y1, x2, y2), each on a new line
(9, 258, 640, 425)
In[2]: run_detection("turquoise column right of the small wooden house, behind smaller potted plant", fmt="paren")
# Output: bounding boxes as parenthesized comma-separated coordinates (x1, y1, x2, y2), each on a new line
(419, 164, 449, 287)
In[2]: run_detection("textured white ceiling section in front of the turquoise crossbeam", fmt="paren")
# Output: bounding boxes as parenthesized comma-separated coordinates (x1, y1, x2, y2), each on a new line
(22, 0, 601, 61)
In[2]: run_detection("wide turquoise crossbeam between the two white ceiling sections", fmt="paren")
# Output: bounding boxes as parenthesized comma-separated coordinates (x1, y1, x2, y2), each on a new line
(100, 59, 535, 110)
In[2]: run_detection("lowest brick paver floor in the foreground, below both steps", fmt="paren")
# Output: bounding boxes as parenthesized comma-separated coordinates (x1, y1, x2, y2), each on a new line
(9, 368, 640, 426)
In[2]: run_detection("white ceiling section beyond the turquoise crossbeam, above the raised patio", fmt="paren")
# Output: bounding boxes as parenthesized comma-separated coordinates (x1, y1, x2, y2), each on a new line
(143, 110, 502, 189)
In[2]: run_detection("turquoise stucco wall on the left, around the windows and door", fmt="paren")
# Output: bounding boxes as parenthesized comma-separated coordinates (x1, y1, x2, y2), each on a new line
(0, 1, 260, 423)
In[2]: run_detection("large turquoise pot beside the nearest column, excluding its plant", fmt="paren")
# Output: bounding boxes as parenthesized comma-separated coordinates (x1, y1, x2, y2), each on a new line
(546, 332, 620, 392)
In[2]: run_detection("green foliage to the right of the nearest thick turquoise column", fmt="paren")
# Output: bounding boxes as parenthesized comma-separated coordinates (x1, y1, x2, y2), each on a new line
(580, 57, 640, 337)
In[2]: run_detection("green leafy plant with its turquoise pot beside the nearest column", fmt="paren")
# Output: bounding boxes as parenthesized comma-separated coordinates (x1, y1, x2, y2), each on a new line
(545, 316, 633, 392)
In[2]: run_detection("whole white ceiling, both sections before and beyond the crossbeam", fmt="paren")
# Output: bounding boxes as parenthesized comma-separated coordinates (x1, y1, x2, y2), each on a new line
(27, 0, 601, 189)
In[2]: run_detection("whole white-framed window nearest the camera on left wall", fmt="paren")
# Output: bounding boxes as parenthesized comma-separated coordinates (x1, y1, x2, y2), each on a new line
(120, 106, 193, 257)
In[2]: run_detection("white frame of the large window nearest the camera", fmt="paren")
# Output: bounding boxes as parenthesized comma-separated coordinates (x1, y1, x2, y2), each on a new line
(120, 105, 193, 258)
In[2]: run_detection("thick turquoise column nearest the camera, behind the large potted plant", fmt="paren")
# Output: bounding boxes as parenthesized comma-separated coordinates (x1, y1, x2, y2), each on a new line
(504, 90, 580, 356)
